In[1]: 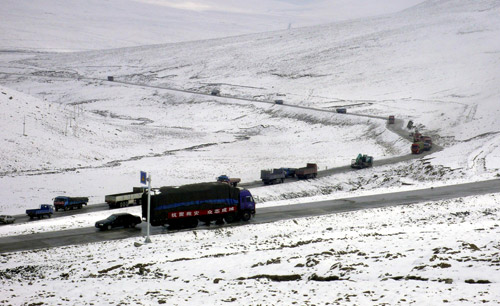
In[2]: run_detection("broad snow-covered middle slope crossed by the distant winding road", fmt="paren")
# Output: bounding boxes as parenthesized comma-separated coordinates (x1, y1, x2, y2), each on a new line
(0, 0, 500, 212)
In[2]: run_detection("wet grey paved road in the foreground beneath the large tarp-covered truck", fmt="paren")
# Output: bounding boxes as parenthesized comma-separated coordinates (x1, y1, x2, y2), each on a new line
(0, 179, 500, 253)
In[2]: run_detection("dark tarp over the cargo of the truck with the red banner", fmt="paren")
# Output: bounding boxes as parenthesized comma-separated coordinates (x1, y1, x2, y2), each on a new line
(142, 183, 239, 220)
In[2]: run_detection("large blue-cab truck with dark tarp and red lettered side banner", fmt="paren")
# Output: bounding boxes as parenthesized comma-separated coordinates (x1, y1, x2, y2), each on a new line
(142, 182, 255, 228)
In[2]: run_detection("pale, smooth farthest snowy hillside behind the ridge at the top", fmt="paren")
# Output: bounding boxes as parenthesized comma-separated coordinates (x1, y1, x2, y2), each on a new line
(0, 0, 423, 52)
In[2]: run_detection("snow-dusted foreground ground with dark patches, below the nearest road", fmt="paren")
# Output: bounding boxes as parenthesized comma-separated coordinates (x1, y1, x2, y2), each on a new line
(0, 194, 500, 305)
